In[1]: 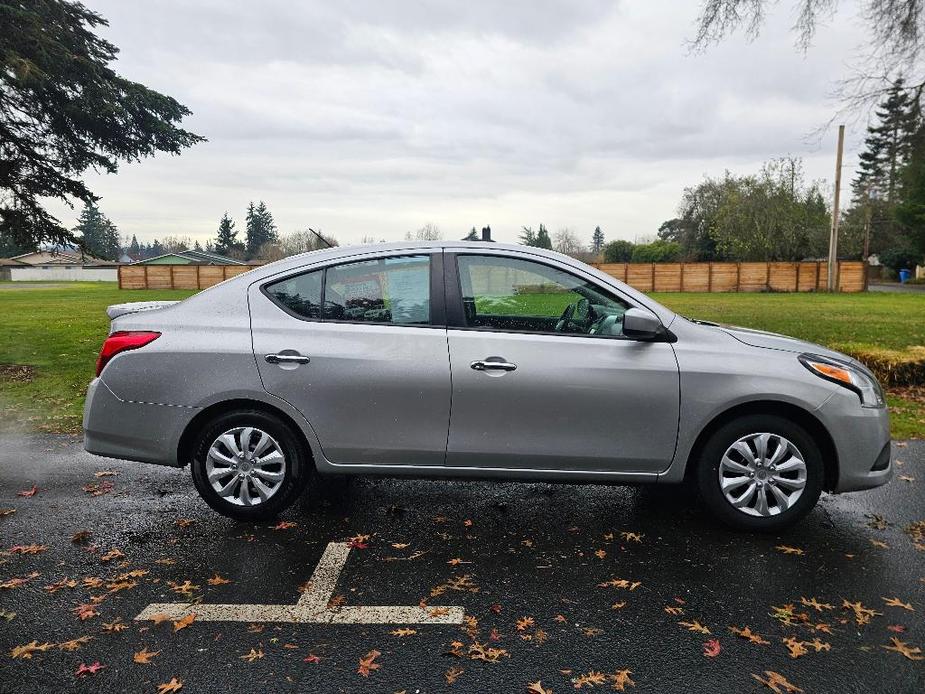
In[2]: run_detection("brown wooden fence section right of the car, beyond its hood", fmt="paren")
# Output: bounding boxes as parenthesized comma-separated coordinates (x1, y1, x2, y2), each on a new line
(594, 261, 867, 292)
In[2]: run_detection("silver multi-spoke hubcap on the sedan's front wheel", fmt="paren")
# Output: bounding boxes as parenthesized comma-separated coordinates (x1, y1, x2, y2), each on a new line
(719, 433, 806, 516)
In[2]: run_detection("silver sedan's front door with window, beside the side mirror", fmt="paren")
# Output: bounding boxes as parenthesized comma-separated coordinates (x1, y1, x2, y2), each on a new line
(447, 253, 679, 473)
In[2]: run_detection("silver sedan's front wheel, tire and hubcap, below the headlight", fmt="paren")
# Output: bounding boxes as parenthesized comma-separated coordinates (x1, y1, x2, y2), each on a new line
(697, 415, 824, 531)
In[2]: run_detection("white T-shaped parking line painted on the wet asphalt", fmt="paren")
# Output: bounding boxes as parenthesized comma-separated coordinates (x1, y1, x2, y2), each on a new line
(135, 542, 464, 624)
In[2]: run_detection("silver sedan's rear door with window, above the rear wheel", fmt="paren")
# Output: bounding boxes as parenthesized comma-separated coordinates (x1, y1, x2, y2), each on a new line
(250, 252, 450, 466)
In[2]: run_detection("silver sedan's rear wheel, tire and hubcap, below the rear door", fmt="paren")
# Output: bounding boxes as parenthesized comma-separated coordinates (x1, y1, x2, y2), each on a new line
(192, 410, 314, 521)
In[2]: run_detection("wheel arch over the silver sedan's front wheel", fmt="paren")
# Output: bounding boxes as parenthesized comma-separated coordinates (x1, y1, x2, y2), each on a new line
(684, 400, 838, 491)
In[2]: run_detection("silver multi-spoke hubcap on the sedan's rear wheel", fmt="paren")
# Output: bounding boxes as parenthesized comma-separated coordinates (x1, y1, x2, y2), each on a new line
(206, 427, 286, 506)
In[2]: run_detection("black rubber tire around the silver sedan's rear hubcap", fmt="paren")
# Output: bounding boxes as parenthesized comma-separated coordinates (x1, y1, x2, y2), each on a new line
(190, 410, 315, 521)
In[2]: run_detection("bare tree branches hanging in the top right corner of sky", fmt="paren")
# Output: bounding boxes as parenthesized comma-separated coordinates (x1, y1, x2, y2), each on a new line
(692, 0, 925, 117)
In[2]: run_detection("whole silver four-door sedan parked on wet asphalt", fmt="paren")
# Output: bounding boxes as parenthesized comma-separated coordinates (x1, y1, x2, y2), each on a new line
(84, 242, 892, 530)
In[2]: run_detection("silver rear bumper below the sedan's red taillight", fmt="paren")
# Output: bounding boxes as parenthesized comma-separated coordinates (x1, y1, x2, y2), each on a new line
(83, 378, 198, 466)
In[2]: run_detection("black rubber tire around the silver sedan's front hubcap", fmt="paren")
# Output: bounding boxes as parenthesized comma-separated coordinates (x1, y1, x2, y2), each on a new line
(696, 414, 825, 532)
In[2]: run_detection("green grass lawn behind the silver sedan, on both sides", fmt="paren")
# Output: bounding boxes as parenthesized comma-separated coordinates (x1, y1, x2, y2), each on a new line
(0, 282, 925, 438)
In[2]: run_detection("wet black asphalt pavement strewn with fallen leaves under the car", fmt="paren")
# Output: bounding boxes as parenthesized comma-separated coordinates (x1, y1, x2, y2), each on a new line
(0, 436, 925, 694)
